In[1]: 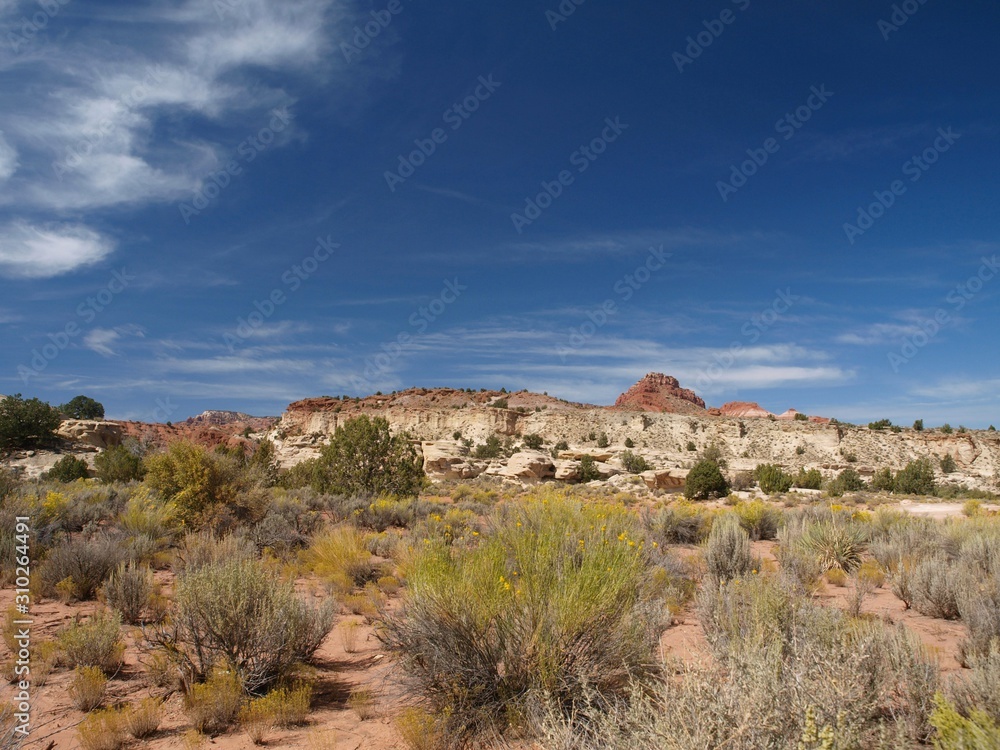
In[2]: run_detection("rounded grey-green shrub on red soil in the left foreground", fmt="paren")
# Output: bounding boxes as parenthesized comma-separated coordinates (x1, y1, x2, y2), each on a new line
(152, 559, 333, 692)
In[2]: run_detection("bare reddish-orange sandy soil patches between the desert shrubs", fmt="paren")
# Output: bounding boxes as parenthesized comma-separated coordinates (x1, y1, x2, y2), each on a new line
(0, 503, 984, 750)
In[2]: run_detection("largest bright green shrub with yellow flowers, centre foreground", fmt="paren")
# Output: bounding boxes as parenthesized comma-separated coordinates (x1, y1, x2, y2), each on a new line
(378, 495, 665, 739)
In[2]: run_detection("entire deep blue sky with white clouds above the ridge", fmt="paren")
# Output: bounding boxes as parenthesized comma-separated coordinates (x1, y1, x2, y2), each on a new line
(0, 0, 1000, 427)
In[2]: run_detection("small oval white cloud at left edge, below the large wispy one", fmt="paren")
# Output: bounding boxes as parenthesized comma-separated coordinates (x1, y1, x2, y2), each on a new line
(0, 220, 115, 279)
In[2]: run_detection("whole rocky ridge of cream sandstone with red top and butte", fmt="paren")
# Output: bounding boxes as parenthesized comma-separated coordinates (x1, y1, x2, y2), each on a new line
(268, 374, 1000, 489)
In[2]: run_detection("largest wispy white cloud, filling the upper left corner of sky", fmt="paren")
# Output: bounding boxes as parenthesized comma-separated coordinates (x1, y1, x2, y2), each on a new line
(0, 0, 334, 212)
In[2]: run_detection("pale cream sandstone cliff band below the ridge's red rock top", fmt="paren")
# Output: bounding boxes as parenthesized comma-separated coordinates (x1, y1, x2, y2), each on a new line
(269, 405, 1000, 491)
